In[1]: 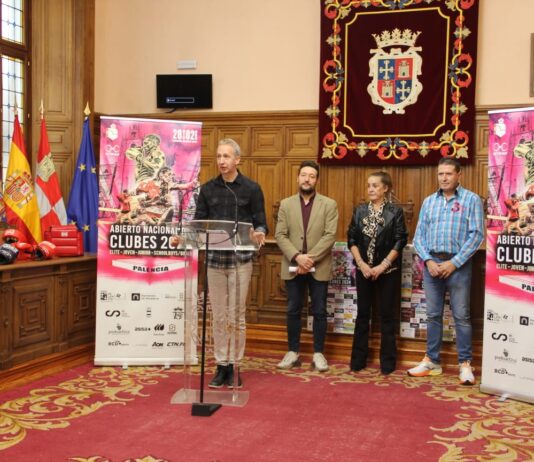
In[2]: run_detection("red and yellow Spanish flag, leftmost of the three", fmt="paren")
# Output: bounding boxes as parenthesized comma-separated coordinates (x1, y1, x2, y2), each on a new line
(4, 115, 42, 244)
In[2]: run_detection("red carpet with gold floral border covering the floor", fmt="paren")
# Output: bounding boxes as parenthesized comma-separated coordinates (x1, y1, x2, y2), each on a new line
(0, 358, 534, 462)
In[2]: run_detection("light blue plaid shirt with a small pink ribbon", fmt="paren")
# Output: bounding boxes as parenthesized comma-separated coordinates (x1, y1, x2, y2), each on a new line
(413, 185, 484, 268)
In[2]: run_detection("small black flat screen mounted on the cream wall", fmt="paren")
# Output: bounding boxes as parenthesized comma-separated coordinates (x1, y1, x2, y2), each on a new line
(156, 74, 213, 109)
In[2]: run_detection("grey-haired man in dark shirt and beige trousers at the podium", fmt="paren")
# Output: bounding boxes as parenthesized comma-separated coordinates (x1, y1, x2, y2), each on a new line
(195, 138, 267, 388)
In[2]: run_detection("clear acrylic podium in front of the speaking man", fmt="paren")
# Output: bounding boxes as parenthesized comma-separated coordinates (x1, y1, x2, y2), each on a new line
(171, 220, 259, 416)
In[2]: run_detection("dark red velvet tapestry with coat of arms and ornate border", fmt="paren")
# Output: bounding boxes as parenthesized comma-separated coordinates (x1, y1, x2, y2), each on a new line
(319, 0, 478, 165)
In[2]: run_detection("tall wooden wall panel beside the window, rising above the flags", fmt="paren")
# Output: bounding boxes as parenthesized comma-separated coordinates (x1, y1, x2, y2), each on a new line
(32, 0, 95, 204)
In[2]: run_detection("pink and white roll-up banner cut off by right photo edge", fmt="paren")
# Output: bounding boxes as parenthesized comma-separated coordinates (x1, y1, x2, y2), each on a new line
(480, 108, 534, 402)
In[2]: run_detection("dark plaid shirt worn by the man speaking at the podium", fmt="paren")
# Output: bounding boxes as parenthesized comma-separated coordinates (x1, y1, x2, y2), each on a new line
(195, 172, 267, 269)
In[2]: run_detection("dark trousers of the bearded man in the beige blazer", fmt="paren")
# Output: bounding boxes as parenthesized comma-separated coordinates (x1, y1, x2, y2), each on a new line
(286, 273, 328, 353)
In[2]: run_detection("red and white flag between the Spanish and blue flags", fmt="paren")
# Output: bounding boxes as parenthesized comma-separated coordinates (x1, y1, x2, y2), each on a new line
(35, 118, 67, 231)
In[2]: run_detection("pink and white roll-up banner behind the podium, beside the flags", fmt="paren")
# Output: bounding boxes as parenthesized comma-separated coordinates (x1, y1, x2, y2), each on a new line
(95, 117, 202, 367)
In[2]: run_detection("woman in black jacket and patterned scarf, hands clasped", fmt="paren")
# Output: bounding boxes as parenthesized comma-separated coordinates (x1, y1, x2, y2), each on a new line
(347, 172, 408, 375)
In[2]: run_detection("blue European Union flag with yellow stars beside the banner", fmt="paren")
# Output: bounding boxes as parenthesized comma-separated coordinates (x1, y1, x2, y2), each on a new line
(67, 118, 98, 253)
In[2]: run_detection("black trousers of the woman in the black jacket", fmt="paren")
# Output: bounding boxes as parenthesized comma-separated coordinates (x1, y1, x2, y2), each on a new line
(350, 270, 400, 372)
